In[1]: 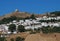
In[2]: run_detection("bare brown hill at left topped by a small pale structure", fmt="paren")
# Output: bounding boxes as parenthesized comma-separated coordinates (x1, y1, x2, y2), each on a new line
(0, 11, 31, 20)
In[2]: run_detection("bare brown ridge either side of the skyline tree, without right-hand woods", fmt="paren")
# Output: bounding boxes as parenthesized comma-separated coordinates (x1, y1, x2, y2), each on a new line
(0, 10, 46, 20)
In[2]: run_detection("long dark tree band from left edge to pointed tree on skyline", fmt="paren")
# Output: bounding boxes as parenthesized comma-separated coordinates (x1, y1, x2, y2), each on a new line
(0, 14, 35, 24)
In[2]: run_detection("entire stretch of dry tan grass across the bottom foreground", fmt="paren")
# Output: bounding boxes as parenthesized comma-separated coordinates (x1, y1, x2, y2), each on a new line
(6, 32, 60, 41)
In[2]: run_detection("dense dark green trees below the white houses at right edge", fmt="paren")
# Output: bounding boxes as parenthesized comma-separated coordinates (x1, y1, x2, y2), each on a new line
(41, 26, 60, 33)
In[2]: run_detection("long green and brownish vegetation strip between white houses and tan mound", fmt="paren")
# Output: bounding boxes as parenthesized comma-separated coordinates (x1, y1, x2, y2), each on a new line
(30, 26, 60, 34)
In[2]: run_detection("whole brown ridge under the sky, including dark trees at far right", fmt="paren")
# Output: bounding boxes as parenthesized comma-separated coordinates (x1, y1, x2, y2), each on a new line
(0, 10, 60, 20)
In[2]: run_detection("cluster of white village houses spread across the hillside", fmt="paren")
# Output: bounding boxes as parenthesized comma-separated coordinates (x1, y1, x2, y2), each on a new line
(0, 16, 60, 34)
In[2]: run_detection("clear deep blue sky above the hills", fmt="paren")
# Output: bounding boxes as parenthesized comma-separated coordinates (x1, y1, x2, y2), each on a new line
(0, 0, 60, 16)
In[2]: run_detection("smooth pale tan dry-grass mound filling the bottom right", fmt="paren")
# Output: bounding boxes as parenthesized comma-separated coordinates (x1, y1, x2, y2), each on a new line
(25, 33, 60, 41)
